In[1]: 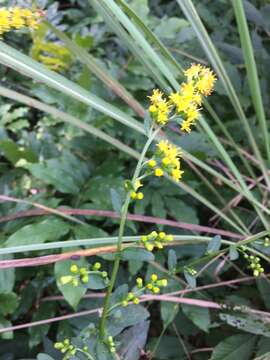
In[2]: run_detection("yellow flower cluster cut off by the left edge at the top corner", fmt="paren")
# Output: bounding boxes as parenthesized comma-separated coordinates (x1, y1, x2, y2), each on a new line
(0, 7, 42, 36)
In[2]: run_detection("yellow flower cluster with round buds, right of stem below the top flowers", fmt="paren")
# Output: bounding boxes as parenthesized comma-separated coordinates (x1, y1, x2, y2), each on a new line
(148, 140, 184, 181)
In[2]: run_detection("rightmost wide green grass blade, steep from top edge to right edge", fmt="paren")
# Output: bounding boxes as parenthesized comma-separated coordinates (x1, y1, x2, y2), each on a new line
(232, 0, 270, 161)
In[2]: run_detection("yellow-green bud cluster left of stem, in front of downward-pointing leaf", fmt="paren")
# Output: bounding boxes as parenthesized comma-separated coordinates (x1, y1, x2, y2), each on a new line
(60, 262, 108, 286)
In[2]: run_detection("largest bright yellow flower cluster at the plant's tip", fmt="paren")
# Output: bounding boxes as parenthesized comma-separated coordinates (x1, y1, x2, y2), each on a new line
(169, 64, 216, 133)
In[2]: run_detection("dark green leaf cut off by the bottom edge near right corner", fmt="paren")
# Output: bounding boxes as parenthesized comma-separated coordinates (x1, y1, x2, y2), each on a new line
(211, 335, 256, 360)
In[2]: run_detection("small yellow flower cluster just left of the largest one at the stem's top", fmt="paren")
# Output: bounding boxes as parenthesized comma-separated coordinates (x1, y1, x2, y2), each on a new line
(148, 89, 170, 126)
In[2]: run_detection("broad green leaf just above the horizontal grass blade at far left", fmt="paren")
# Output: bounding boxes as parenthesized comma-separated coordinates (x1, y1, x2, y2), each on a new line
(5, 217, 69, 247)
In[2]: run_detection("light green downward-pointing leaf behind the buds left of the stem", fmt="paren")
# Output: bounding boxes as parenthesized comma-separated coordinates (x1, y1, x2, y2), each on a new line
(54, 259, 87, 308)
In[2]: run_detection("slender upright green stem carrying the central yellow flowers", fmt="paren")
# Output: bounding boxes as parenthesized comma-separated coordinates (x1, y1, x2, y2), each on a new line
(100, 128, 160, 340)
